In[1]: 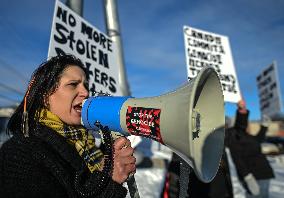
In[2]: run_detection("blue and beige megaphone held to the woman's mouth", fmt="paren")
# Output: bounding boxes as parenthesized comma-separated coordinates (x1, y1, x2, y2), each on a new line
(82, 67, 225, 182)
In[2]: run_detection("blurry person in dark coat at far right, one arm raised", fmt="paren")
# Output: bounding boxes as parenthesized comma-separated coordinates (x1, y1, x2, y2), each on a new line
(227, 100, 274, 198)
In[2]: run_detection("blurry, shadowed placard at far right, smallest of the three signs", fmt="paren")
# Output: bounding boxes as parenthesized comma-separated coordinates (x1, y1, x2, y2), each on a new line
(256, 62, 282, 116)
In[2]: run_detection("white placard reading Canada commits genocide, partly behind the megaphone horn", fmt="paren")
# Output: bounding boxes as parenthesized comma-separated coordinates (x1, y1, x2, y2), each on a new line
(183, 26, 241, 103)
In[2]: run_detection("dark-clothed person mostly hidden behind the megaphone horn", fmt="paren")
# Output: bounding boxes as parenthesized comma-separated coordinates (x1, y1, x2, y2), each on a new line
(161, 117, 233, 198)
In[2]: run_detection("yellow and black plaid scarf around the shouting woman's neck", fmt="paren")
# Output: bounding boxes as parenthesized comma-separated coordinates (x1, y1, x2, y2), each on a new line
(39, 109, 103, 173)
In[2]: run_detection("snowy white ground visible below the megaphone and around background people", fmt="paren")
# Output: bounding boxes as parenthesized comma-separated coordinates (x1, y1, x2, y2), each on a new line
(127, 143, 284, 198)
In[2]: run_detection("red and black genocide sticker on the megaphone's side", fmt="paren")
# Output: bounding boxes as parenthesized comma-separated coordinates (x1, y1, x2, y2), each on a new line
(126, 106, 164, 144)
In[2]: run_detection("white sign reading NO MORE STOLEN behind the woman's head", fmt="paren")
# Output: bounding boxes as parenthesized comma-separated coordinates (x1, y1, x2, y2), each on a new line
(48, 1, 122, 96)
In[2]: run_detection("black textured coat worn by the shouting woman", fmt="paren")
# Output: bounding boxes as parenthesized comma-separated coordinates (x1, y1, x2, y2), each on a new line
(0, 126, 127, 198)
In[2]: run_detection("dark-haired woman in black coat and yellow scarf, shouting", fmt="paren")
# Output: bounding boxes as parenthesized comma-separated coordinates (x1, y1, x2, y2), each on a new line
(0, 55, 136, 198)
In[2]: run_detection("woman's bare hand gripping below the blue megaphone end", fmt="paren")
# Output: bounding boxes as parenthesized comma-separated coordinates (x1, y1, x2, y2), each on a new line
(112, 137, 136, 184)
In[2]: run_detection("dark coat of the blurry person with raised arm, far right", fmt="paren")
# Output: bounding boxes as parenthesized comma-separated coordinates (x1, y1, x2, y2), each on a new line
(226, 112, 274, 180)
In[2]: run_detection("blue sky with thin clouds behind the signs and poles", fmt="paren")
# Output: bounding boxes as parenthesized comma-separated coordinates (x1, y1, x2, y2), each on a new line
(0, 0, 284, 119)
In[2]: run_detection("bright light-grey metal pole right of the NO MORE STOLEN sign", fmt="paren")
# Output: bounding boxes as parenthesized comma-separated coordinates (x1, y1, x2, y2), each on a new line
(104, 0, 131, 96)
